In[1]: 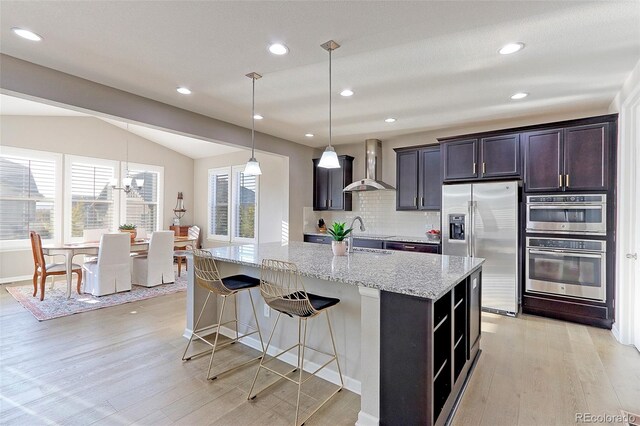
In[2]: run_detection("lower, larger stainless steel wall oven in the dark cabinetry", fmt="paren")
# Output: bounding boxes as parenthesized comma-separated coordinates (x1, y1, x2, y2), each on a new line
(526, 237, 607, 302)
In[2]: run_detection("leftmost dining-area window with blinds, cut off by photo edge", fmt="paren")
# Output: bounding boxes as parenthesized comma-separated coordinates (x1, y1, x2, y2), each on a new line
(0, 147, 62, 247)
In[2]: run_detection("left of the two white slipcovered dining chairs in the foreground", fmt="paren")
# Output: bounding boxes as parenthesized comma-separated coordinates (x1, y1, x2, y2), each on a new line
(82, 232, 131, 296)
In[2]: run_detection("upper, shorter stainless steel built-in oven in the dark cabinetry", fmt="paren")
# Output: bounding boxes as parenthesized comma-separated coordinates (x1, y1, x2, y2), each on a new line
(527, 194, 607, 235)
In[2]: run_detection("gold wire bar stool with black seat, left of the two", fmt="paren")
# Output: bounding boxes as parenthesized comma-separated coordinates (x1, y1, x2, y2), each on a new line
(182, 249, 264, 380)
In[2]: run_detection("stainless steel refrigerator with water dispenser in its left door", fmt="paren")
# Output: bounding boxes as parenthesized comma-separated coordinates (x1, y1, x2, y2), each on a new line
(442, 181, 520, 315)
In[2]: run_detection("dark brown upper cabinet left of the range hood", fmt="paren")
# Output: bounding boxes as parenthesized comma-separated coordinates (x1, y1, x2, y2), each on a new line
(313, 155, 353, 211)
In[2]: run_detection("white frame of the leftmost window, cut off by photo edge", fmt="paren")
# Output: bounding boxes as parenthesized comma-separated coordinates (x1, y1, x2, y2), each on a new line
(0, 145, 63, 251)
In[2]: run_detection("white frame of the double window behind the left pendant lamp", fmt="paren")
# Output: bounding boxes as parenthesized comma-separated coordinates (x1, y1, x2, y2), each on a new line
(207, 165, 260, 243)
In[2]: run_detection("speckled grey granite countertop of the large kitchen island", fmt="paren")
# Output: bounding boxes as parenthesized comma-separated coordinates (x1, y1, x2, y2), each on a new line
(208, 242, 484, 299)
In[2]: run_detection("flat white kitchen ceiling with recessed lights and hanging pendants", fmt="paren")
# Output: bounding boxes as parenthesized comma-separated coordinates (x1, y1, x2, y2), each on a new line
(0, 0, 640, 146)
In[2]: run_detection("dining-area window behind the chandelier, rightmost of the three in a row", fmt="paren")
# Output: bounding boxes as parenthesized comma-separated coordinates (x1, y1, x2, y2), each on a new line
(122, 163, 164, 234)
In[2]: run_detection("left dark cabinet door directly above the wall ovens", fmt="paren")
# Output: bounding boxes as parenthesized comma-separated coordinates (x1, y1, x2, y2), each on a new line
(523, 129, 563, 192)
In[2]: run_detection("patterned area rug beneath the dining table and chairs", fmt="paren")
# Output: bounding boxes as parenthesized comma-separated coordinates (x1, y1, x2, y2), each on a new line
(6, 274, 187, 321)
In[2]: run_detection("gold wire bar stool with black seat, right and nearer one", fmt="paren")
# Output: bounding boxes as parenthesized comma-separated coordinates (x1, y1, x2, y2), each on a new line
(247, 259, 344, 425)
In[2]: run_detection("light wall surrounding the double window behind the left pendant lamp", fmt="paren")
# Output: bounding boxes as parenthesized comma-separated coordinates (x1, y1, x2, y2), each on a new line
(193, 151, 289, 247)
